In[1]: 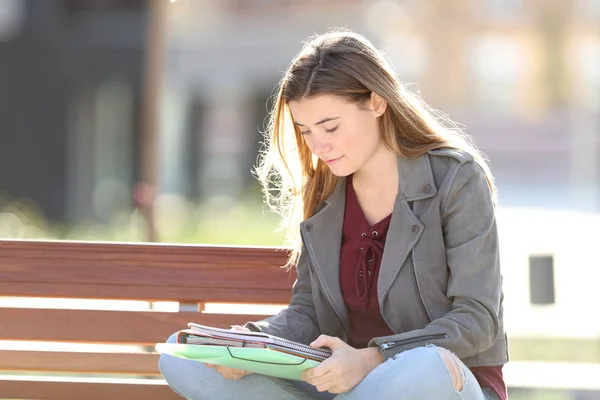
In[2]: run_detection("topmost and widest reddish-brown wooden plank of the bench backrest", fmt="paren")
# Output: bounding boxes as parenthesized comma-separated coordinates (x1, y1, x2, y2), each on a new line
(0, 240, 295, 302)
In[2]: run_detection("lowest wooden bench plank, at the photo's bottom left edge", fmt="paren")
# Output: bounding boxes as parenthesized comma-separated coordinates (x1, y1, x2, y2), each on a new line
(0, 377, 181, 400)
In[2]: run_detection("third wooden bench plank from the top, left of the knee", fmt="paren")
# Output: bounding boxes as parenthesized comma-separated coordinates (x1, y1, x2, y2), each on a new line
(0, 350, 160, 376)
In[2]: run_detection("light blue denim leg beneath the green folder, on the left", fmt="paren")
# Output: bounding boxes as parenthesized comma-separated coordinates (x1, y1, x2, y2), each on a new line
(159, 336, 314, 400)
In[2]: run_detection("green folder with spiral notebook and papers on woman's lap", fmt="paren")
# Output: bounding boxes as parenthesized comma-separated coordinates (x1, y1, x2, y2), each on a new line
(156, 323, 331, 380)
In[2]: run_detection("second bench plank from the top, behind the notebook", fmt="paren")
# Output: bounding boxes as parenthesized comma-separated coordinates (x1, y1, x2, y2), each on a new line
(0, 308, 265, 346)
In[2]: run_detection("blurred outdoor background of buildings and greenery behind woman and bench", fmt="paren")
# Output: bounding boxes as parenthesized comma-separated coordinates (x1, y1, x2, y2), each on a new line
(0, 0, 600, 400)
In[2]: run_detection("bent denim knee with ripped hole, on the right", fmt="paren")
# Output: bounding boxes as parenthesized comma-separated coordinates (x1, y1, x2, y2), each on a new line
(336, 346, 485, 400)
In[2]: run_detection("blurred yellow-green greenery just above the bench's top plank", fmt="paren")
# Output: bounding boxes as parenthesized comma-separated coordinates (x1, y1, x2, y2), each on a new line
(0, 194, 285, 246)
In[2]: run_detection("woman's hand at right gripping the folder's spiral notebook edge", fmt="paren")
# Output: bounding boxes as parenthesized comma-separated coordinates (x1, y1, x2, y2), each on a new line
(302, 335, 383, 393)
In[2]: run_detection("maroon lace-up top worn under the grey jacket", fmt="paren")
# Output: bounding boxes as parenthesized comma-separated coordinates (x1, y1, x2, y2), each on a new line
(340, 176, 508, 400)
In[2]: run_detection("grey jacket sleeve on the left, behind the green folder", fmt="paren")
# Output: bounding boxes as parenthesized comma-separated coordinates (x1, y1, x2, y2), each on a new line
(245, 249, 319, 344)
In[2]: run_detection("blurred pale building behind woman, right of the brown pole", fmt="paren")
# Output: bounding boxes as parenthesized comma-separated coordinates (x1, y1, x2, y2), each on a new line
(162, 0, 600, 211)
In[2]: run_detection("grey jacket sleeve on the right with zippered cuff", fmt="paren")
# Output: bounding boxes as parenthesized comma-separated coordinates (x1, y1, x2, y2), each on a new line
(369, 162, 502, 359)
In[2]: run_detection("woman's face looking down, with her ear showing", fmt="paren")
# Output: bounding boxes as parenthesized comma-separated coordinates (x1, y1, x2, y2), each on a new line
(289, 95, 386, 176)
